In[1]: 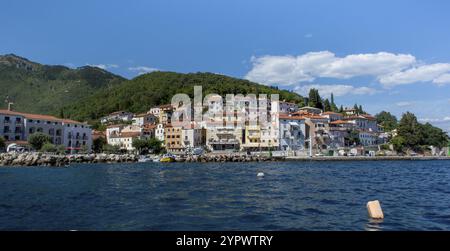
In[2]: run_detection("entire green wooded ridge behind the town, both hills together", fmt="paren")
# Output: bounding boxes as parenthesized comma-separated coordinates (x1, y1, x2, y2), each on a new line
(0, 54, 304, 122)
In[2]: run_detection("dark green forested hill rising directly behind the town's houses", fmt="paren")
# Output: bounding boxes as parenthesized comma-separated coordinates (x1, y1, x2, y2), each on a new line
(63, 72, 303, 121)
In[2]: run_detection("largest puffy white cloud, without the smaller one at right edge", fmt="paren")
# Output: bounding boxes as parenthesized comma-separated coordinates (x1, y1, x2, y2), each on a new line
(245, 51, 416, 85)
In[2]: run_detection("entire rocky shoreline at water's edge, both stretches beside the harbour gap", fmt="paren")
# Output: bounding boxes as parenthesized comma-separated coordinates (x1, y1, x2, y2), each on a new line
(0, 153, 450, 167)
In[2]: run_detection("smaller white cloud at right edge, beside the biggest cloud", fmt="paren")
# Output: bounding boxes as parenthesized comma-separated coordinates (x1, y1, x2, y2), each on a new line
(379, 64, 450, 86)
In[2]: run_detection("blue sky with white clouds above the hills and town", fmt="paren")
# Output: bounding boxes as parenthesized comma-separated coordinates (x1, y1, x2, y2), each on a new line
(0, 0, 450, 131)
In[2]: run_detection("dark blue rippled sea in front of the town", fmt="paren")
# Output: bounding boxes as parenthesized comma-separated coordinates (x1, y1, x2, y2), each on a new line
(0, 161, 450, 230)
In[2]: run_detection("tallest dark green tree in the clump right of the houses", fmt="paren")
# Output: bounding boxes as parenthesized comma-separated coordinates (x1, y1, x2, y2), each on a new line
(398, 112, 422, 148)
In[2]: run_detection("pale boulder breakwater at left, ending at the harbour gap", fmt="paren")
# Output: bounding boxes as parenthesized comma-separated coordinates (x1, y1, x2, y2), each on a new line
(0, 153, 139, 167)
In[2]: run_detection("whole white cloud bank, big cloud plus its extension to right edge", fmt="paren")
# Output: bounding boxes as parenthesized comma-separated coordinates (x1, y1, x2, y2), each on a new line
(245, 51, 450, 88)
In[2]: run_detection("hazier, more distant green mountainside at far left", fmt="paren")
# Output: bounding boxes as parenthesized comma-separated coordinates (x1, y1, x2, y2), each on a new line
(0, 54, 125, 115)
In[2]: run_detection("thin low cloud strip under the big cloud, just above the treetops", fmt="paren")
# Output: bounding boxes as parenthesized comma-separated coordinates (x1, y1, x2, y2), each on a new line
(294, 84, 378, 97)
